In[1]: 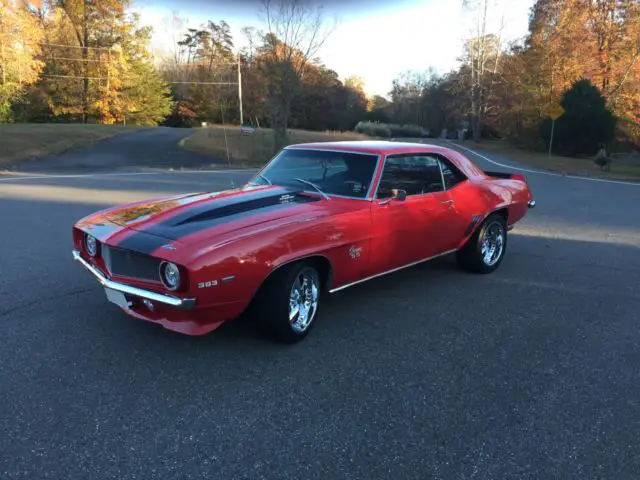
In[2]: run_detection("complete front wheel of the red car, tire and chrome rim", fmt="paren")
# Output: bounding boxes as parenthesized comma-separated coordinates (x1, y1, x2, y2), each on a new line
(254, 261, 322, 343)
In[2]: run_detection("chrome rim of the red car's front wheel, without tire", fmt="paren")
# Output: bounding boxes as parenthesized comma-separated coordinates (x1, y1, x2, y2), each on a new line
(289, 268, 320, 332)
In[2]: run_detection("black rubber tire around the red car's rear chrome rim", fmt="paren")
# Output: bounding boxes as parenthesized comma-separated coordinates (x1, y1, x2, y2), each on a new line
(456, 213, 508, 274)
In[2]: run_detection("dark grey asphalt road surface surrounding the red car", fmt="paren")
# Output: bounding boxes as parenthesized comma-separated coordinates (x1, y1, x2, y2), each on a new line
(0, 140, 640, 480)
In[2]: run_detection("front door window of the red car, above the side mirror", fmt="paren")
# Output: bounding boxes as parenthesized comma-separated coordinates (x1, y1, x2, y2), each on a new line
(377, 155, 444, 198)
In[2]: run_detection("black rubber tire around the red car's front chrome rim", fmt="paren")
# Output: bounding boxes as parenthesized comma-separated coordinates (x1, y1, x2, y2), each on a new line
(252, 261, 323, 343)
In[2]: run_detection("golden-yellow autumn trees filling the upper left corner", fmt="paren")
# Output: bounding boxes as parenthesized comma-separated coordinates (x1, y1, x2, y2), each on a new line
(0, 0, 173, 125)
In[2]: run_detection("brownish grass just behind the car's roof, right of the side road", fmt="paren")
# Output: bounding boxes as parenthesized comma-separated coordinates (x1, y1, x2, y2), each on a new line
(181, 125, 370, 167)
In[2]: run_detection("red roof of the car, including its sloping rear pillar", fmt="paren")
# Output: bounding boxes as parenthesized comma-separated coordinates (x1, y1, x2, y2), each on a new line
(285, 140, 485, 178)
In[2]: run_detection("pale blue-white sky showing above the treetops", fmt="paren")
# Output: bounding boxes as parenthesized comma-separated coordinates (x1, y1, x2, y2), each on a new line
(134, 0, 533, 95)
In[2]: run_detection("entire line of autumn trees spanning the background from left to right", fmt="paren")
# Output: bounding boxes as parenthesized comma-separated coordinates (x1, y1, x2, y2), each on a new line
(0, 0, 640, 151)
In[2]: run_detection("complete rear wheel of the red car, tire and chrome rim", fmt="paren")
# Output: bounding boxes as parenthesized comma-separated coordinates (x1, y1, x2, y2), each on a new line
(456, 213, 507, 273)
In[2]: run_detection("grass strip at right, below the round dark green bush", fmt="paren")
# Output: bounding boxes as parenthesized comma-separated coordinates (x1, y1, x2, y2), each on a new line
(462, 140, 640, 180)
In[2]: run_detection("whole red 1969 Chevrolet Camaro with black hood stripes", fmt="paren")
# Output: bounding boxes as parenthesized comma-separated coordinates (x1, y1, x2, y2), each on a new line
(73, 141, 535, 342)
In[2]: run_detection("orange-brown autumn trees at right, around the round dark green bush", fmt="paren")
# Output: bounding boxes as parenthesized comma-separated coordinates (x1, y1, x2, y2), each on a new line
(388, 0, 640, 151)
